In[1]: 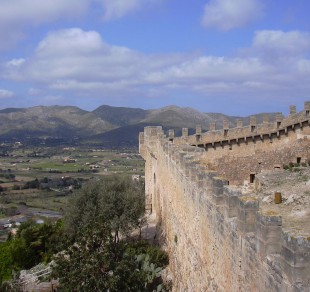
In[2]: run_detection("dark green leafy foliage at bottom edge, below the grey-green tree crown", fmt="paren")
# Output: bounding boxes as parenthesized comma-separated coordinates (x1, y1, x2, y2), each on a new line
(53, 222, 167, 292)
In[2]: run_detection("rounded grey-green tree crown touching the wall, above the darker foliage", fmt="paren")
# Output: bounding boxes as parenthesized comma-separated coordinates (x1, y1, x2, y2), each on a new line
(65, 177, 144, 241)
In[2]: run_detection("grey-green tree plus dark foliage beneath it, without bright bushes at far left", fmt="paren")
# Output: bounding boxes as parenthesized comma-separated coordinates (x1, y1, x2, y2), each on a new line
(53, 177, 168, 292)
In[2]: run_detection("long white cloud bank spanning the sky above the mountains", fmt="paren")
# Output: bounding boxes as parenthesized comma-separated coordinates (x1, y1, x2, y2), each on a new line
(2, 28, 310, 102)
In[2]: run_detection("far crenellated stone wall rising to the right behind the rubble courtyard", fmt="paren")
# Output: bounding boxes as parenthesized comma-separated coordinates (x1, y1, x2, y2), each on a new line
(170, 102, 310, 185)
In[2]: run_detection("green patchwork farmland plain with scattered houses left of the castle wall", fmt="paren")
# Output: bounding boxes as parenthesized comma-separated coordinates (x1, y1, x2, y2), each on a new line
(0, 145, 144, 240)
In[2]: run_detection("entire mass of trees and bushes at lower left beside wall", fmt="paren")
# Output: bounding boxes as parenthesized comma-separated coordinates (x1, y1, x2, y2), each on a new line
(0, 177, 168, 292)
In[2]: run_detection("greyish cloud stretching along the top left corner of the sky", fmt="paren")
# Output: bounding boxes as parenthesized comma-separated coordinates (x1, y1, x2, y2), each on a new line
(0, 0, 158, 50)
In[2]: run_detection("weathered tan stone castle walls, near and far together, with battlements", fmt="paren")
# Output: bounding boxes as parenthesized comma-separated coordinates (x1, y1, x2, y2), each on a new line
(140, 102, 310, 291)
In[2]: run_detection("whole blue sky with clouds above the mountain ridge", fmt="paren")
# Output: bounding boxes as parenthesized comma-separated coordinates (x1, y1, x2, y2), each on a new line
(0, 0, 310, 115)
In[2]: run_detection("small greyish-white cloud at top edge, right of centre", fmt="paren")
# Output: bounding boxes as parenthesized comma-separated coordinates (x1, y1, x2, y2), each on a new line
(202, 0, 263, 31)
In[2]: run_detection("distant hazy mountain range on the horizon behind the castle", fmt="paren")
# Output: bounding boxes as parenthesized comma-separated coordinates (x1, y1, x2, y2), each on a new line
(0, 105, 275, 147)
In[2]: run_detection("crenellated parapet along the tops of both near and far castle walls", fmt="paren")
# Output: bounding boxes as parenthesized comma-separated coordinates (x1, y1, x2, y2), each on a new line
(139, 106, 310, 291)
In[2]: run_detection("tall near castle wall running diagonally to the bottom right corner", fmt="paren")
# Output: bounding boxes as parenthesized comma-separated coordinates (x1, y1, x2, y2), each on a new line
(140, 101, 310, 291)
